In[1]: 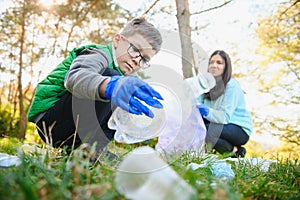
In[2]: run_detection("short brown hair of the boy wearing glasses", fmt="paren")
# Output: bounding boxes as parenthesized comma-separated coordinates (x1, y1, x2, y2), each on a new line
(121, 17, 162, 52)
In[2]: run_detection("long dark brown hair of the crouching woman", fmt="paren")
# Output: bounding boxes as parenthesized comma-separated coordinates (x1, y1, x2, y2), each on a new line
(204, 50, 232, 100)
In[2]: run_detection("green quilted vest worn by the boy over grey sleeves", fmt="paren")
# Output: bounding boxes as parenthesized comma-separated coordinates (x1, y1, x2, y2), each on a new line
(28, 43, 122, 122)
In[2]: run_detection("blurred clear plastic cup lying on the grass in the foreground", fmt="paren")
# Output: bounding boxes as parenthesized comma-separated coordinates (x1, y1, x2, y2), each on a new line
(115, 146, 197, 200)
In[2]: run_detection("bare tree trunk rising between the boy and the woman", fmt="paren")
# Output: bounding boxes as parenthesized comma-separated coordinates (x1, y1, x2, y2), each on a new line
(176, 0, 194, 78)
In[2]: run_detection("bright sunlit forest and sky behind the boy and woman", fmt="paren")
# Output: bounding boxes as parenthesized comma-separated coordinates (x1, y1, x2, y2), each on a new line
(0, 0, 300, 158)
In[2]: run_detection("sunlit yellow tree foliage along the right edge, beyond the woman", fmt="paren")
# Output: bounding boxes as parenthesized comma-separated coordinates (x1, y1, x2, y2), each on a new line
(256, 0, 300, 147)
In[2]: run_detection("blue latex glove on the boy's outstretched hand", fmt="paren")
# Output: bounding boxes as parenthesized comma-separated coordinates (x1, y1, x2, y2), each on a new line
(105, 76, 163, 118)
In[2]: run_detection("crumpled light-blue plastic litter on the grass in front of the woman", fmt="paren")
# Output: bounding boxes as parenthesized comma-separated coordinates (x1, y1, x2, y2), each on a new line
(210, 160, 235, 180)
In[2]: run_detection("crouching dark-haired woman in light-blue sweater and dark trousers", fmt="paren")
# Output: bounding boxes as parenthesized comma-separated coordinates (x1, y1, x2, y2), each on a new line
(197, 50, 252, 157)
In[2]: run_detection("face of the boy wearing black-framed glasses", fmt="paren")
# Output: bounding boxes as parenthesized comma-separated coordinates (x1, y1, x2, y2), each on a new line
(113, 34, 156, 75)
